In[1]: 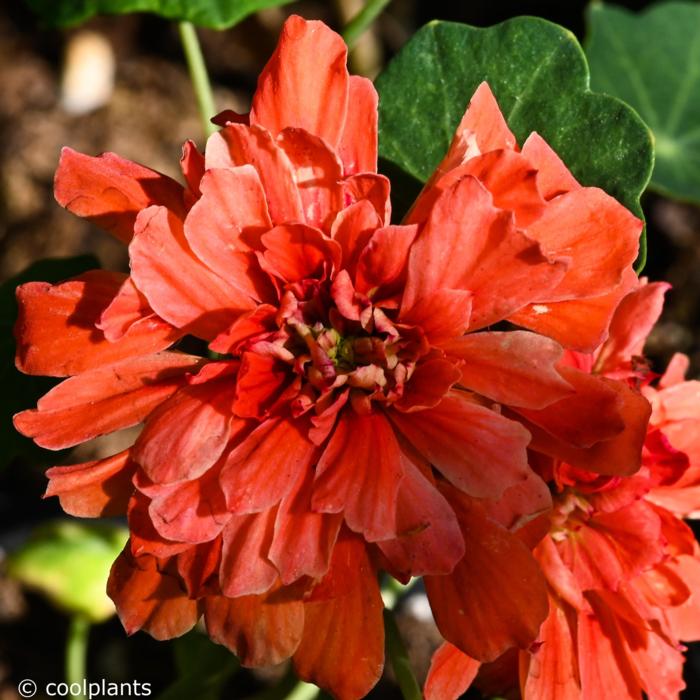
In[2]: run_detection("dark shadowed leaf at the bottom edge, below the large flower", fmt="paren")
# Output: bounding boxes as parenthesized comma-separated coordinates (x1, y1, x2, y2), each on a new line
(157, 629, 238, 700)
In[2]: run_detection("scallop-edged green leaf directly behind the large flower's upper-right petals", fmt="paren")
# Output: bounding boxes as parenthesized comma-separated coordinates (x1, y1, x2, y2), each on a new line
(377, 17, 653, 264)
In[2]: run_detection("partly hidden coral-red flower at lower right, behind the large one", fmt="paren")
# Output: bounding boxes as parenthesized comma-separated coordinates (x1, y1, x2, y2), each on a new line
(426, 282, 700, 700)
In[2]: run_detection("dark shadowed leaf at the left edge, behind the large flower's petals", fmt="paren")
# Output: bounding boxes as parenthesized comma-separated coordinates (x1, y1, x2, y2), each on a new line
(0, 255, 99, 469)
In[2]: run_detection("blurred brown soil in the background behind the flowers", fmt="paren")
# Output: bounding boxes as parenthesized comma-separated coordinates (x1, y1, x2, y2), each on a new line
(0, 0, 700, 700)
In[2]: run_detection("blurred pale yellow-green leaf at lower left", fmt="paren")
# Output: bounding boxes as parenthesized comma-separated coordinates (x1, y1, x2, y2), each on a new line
(7, 521, 129, 622)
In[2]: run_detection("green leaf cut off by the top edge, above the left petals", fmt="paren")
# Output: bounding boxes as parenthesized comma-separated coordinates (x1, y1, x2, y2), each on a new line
(25, 0, 292, 29)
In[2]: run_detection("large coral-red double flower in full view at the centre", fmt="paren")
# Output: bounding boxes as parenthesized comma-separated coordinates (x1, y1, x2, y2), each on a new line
(15, 12, 648, 698)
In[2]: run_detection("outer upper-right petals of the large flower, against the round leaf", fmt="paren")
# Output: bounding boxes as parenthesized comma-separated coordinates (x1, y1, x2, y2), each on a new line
(408, 83, 642, 352)
